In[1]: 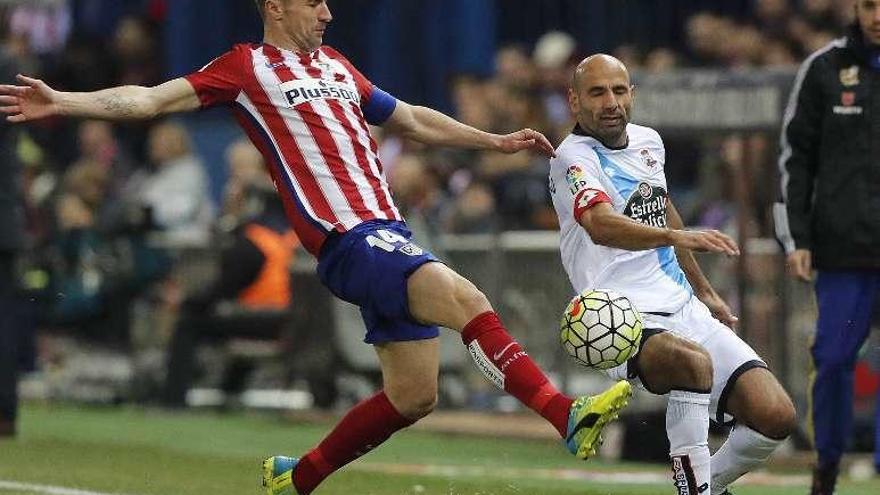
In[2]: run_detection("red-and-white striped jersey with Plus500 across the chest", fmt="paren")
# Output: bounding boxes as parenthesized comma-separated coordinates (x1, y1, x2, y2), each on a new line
(186, 44, 402, 256)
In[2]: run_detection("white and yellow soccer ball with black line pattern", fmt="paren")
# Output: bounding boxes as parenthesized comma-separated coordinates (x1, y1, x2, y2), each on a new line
(559, 289, 642, 370)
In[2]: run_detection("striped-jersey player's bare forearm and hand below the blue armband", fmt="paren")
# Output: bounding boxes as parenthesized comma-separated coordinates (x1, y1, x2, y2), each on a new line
(385, 100, 556, 156)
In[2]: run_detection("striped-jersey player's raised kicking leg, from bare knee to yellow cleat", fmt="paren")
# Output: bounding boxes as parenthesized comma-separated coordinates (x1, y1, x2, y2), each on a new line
(407, 263, 631, 458)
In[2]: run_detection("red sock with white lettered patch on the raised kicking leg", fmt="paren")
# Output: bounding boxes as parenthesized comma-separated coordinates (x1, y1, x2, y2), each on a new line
(461, 311, 572, 438)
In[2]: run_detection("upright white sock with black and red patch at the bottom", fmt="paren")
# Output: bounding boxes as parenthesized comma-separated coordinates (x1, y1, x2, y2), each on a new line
(666, 390, 712, 495)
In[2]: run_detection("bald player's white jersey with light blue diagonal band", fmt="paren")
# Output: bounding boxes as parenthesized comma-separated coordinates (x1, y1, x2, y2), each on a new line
(550, 124, 693, 313)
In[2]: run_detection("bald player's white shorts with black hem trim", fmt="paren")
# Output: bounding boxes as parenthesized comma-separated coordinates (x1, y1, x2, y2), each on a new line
(605, 297, 767, 424)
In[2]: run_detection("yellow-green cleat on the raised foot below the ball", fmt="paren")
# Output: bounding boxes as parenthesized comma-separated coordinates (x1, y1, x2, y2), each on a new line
(565, 380, 632, 459)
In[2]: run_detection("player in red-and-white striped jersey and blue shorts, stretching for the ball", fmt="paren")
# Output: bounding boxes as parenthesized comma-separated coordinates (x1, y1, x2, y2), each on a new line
(0, 0, 631, 495)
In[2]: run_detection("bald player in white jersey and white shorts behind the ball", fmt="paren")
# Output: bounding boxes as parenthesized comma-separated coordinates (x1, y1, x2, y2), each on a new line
(550, 55, 795, 495)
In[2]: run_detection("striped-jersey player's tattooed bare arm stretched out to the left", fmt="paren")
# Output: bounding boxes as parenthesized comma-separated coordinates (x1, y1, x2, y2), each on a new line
(0, 75, 200, 122)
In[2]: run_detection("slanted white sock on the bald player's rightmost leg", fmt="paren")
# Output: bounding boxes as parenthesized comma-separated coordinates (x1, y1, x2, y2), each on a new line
(712, 425, 783, 495)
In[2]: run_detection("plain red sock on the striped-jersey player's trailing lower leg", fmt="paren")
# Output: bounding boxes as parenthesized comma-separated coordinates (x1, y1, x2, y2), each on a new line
(293, 391, 415, 495)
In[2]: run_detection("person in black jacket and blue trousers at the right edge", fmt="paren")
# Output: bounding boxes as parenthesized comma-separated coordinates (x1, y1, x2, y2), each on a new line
(774, 0, 880, 495)
